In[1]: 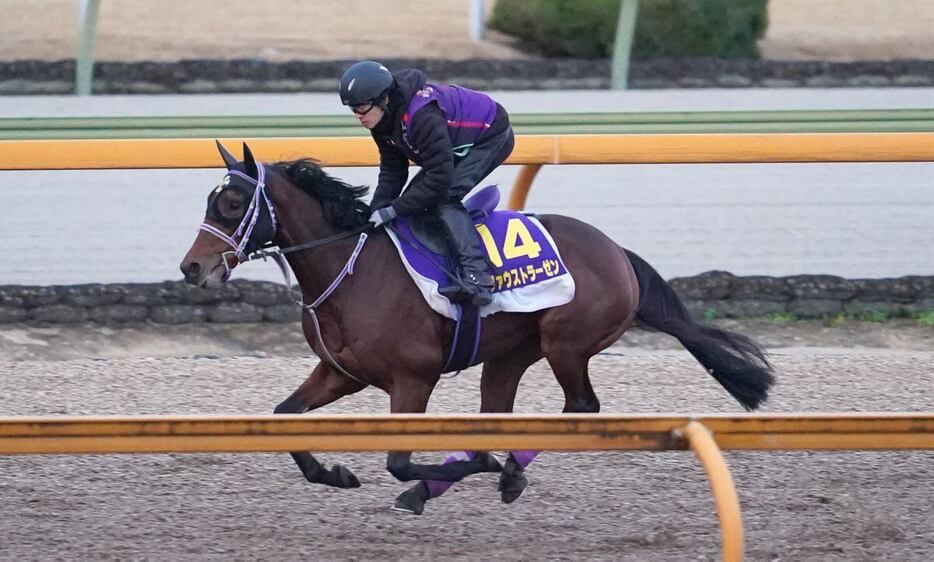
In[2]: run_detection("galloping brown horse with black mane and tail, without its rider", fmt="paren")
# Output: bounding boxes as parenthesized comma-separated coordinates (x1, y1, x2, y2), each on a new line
(180, 142, 774, 513)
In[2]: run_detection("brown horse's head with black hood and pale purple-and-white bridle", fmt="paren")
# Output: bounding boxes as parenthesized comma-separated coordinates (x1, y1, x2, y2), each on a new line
(180, 142, 277, 287)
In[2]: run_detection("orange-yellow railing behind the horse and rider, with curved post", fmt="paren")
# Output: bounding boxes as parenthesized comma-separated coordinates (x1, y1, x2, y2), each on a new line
(0, 133, 934, 208)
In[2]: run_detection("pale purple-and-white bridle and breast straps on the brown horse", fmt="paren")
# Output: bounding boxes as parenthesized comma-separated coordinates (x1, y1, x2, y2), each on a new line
(198, 162, 373, 384)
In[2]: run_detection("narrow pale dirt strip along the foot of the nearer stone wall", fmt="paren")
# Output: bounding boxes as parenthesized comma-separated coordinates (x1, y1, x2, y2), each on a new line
(0, 320, 934, 361)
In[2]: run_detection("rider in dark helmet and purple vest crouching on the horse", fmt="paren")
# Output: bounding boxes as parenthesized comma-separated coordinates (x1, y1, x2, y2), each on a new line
(340, 61, 514, 306)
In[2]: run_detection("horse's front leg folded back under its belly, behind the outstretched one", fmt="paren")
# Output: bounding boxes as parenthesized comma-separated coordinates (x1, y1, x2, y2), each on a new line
(386, 377, 498, 482)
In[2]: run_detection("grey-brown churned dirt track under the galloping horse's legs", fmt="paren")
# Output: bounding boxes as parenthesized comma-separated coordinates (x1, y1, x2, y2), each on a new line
(0, 349, 934, 560)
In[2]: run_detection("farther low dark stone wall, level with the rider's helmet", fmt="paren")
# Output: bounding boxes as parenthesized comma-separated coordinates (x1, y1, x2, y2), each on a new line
(0, 59, 934, 95)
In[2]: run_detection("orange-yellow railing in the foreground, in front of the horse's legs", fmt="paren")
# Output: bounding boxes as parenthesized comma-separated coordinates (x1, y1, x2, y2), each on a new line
(0, 412, 934, 560)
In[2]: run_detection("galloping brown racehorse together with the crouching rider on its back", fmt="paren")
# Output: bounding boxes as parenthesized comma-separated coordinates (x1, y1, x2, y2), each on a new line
(180, 61, 774, 514)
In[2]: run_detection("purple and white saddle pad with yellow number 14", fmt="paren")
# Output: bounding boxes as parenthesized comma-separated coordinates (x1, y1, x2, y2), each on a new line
(386, 211, 574, 319)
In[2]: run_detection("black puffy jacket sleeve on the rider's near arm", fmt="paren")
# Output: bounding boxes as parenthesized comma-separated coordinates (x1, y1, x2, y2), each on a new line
(392, 103, 454, 215)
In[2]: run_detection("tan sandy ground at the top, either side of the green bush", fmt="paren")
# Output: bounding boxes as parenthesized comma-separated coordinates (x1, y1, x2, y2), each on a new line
(0, 0, 934, 61)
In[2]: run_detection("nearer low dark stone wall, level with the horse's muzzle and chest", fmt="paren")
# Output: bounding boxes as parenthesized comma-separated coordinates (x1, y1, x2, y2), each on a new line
(0, 271, 934, 325)
